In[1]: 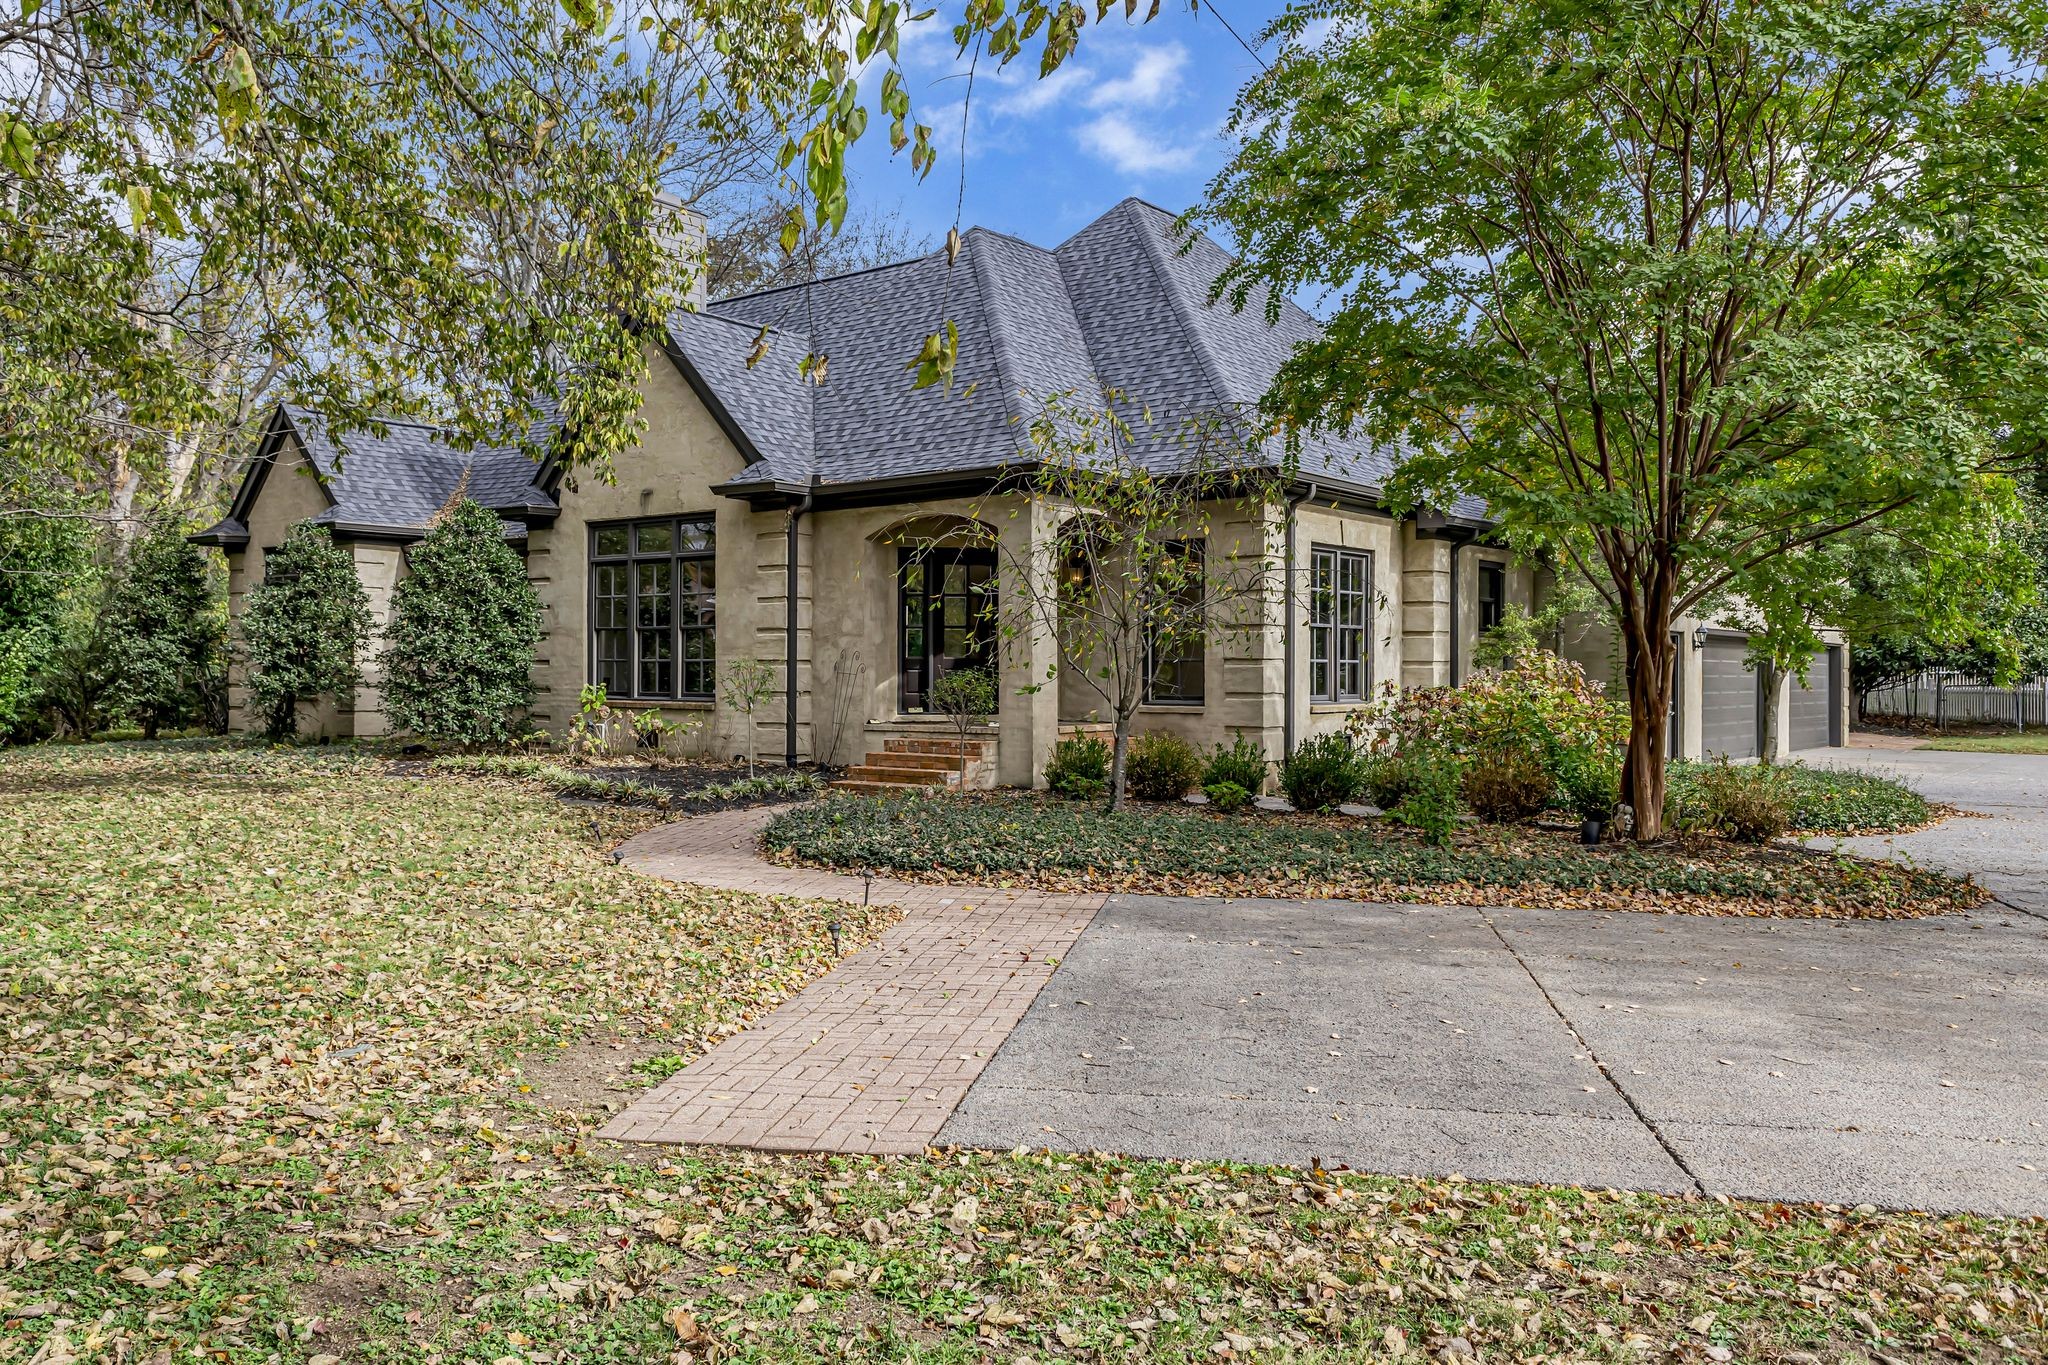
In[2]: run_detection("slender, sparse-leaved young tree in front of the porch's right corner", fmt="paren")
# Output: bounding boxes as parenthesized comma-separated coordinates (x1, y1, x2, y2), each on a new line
(973, 389, 1282, 810)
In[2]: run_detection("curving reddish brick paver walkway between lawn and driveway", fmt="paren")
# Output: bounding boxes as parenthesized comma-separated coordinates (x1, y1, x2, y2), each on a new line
(598, 808, 1104, 1152)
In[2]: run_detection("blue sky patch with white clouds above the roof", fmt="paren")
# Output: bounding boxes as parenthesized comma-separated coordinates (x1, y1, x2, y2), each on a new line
(852, 0, 1280, 246)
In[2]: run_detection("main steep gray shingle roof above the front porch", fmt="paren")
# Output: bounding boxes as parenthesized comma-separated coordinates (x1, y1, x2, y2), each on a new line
(688, 199, 1441, 512)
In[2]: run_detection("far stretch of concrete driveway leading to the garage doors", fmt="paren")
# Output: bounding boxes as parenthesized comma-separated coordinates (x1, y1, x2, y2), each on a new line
(1796, 749, 2048, 915)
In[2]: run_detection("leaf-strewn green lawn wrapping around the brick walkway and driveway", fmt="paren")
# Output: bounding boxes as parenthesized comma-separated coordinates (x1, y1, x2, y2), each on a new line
(0, 745, 2048, 1365)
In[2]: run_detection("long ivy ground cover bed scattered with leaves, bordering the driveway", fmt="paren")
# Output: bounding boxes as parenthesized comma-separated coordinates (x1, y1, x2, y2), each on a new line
(762, 789, 1982, 919)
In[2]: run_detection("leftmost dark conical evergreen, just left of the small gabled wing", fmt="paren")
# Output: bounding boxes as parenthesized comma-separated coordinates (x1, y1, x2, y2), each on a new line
(104, 526, 223, 739)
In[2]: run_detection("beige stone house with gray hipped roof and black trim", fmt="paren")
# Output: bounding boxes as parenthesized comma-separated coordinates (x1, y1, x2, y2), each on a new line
(199, 199, 1839, 786)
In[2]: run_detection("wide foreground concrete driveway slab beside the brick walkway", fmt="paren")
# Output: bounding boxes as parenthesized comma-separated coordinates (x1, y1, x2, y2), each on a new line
(940, 896, 2048, 1214)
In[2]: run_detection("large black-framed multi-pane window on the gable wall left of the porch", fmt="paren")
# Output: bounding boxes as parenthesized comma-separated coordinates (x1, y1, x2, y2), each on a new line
(590, 514, 719, 700)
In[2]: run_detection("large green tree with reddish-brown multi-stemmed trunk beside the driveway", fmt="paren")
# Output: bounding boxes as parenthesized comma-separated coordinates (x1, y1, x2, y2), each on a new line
(1206, 0, 2048, 839)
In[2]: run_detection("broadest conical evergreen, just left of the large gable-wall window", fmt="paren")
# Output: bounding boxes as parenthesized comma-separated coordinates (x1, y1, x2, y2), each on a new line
(381, 497, 541, 745)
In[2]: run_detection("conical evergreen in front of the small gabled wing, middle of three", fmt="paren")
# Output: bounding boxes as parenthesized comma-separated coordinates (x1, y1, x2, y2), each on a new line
(242, 522, 371, 739)
